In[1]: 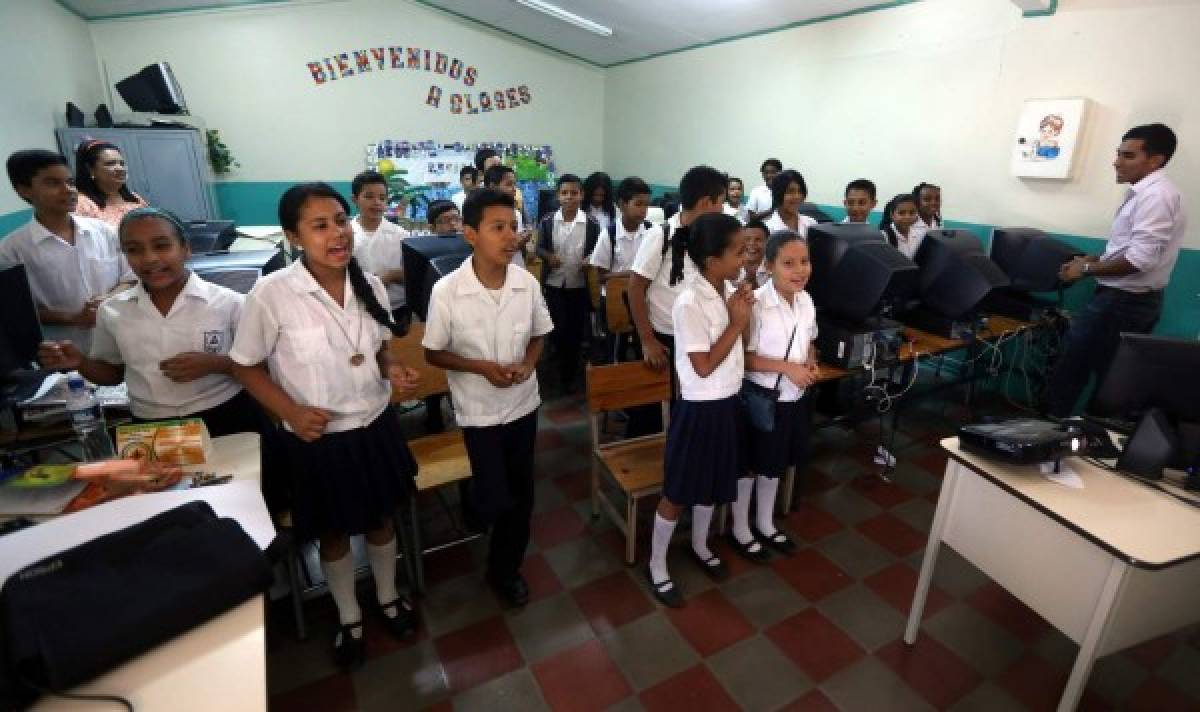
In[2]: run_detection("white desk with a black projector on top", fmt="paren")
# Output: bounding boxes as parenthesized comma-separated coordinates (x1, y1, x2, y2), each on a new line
(905, 438, 1200, 712)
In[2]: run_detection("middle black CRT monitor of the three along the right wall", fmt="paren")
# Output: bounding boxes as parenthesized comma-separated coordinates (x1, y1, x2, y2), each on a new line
(916, 229, 1009, 319)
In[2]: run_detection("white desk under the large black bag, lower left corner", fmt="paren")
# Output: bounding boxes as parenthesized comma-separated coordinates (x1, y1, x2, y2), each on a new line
(0, 433, 275, 712)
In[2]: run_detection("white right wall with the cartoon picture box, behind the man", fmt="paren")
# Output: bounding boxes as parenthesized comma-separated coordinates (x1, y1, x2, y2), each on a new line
(605, 0, 1200, 247)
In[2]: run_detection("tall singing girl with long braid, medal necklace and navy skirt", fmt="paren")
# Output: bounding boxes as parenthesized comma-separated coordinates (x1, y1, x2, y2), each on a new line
(229, 183, 418, 669)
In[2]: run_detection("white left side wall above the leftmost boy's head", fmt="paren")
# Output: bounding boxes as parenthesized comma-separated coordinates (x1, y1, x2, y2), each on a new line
(0, 0, 103, 215)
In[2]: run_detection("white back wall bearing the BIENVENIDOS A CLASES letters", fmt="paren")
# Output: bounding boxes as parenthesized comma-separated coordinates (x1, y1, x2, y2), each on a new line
(90, 0, 604, 181)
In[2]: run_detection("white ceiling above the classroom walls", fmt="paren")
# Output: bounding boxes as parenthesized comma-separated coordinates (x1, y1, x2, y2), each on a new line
(59, 0, 898, 66)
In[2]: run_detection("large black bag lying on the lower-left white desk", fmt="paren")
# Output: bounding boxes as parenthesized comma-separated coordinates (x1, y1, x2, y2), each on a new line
(0, 502, 271, 707)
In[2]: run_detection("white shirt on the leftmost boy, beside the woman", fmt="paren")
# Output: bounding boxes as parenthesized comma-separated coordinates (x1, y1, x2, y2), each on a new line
(0, 215, 134, 353)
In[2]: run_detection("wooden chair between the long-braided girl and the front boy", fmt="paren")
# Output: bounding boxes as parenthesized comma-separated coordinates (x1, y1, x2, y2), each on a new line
(388, 322, 479, 593)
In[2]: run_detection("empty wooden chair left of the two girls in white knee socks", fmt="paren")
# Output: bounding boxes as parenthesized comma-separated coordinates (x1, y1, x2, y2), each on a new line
(587, 362, 671, 564)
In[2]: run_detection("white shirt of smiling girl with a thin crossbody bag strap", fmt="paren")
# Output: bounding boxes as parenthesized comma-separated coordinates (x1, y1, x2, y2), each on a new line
(746, 281, 817, 401)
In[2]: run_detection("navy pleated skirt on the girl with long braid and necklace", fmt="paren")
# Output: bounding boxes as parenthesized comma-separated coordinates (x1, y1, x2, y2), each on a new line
(281, 406, 416, 542)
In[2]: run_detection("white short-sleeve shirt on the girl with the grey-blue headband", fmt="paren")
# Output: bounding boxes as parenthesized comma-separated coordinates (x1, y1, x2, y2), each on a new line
(90, 274, 245, 419)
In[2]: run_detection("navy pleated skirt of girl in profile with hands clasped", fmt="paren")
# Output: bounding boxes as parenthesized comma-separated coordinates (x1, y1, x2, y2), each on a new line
(662, 395, 745, 505)
